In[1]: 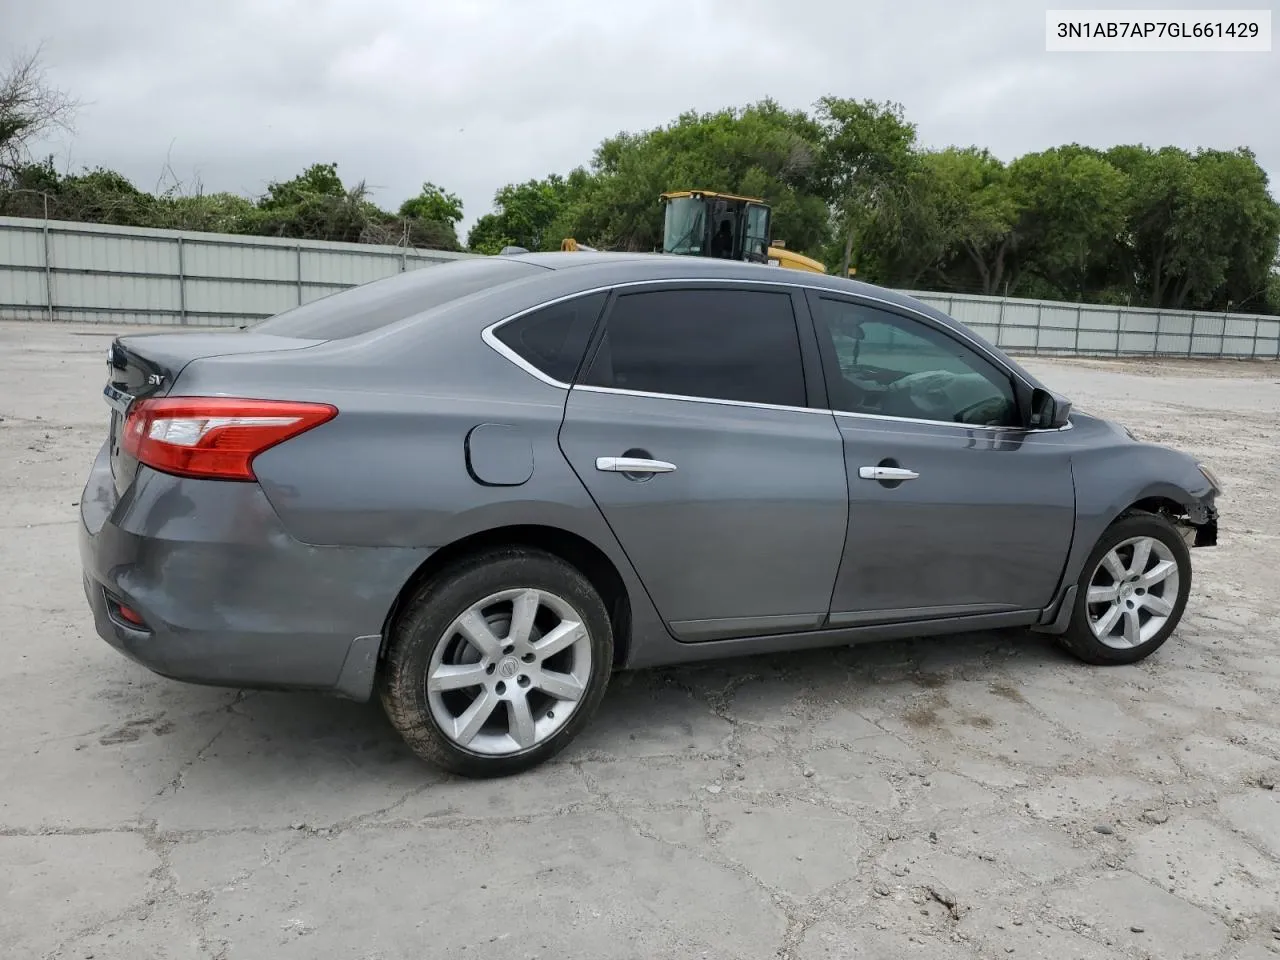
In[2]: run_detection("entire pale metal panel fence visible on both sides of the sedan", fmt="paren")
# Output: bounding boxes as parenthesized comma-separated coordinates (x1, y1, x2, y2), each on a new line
(0, 218, 1280, 360)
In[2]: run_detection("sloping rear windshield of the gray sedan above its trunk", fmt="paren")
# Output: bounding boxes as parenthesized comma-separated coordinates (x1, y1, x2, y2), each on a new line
(248, 257, 544, 340)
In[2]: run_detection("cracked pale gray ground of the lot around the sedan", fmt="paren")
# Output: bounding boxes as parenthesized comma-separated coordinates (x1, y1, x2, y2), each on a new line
(0, 324, 1280, 960)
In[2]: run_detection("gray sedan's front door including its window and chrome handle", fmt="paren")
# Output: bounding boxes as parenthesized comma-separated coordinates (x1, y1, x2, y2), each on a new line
(809, 291, 1075, 626)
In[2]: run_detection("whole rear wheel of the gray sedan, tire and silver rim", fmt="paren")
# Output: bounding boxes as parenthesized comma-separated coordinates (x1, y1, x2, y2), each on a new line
(379, 548, 613, 778)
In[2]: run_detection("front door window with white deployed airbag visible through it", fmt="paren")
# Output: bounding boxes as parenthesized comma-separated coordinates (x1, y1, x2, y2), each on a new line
(819, 300, 1018, 426)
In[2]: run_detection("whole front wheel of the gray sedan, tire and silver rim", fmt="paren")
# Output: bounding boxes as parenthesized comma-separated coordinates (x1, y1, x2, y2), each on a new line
(1059, 512, 1192, 666)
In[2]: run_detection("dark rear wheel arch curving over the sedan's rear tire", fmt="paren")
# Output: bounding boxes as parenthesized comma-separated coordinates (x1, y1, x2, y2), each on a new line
(378, 524, 632, 668)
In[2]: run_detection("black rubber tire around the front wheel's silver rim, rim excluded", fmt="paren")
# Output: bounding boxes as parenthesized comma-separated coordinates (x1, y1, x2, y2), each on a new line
(1064, 513, 1192, 664)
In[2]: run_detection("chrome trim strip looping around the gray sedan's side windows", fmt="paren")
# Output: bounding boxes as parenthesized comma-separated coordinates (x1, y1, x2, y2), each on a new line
(480, 276, 1073, 434)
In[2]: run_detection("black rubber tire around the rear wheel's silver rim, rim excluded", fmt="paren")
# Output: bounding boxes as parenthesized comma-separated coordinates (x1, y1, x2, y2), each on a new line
(381, 550, 613, 777)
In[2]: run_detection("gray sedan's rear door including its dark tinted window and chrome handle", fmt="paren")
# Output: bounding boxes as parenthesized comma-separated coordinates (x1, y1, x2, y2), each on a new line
(561, 284, 849, 641)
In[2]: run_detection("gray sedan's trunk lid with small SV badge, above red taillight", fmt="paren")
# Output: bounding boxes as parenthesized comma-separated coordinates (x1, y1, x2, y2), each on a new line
(102, 333, 324, 495)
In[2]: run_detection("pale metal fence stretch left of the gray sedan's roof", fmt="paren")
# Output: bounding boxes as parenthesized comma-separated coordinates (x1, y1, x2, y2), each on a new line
(0, 216, 467, 326)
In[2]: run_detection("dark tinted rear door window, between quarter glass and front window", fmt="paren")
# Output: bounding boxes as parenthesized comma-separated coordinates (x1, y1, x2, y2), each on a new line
(586, 289, 805, 407)
